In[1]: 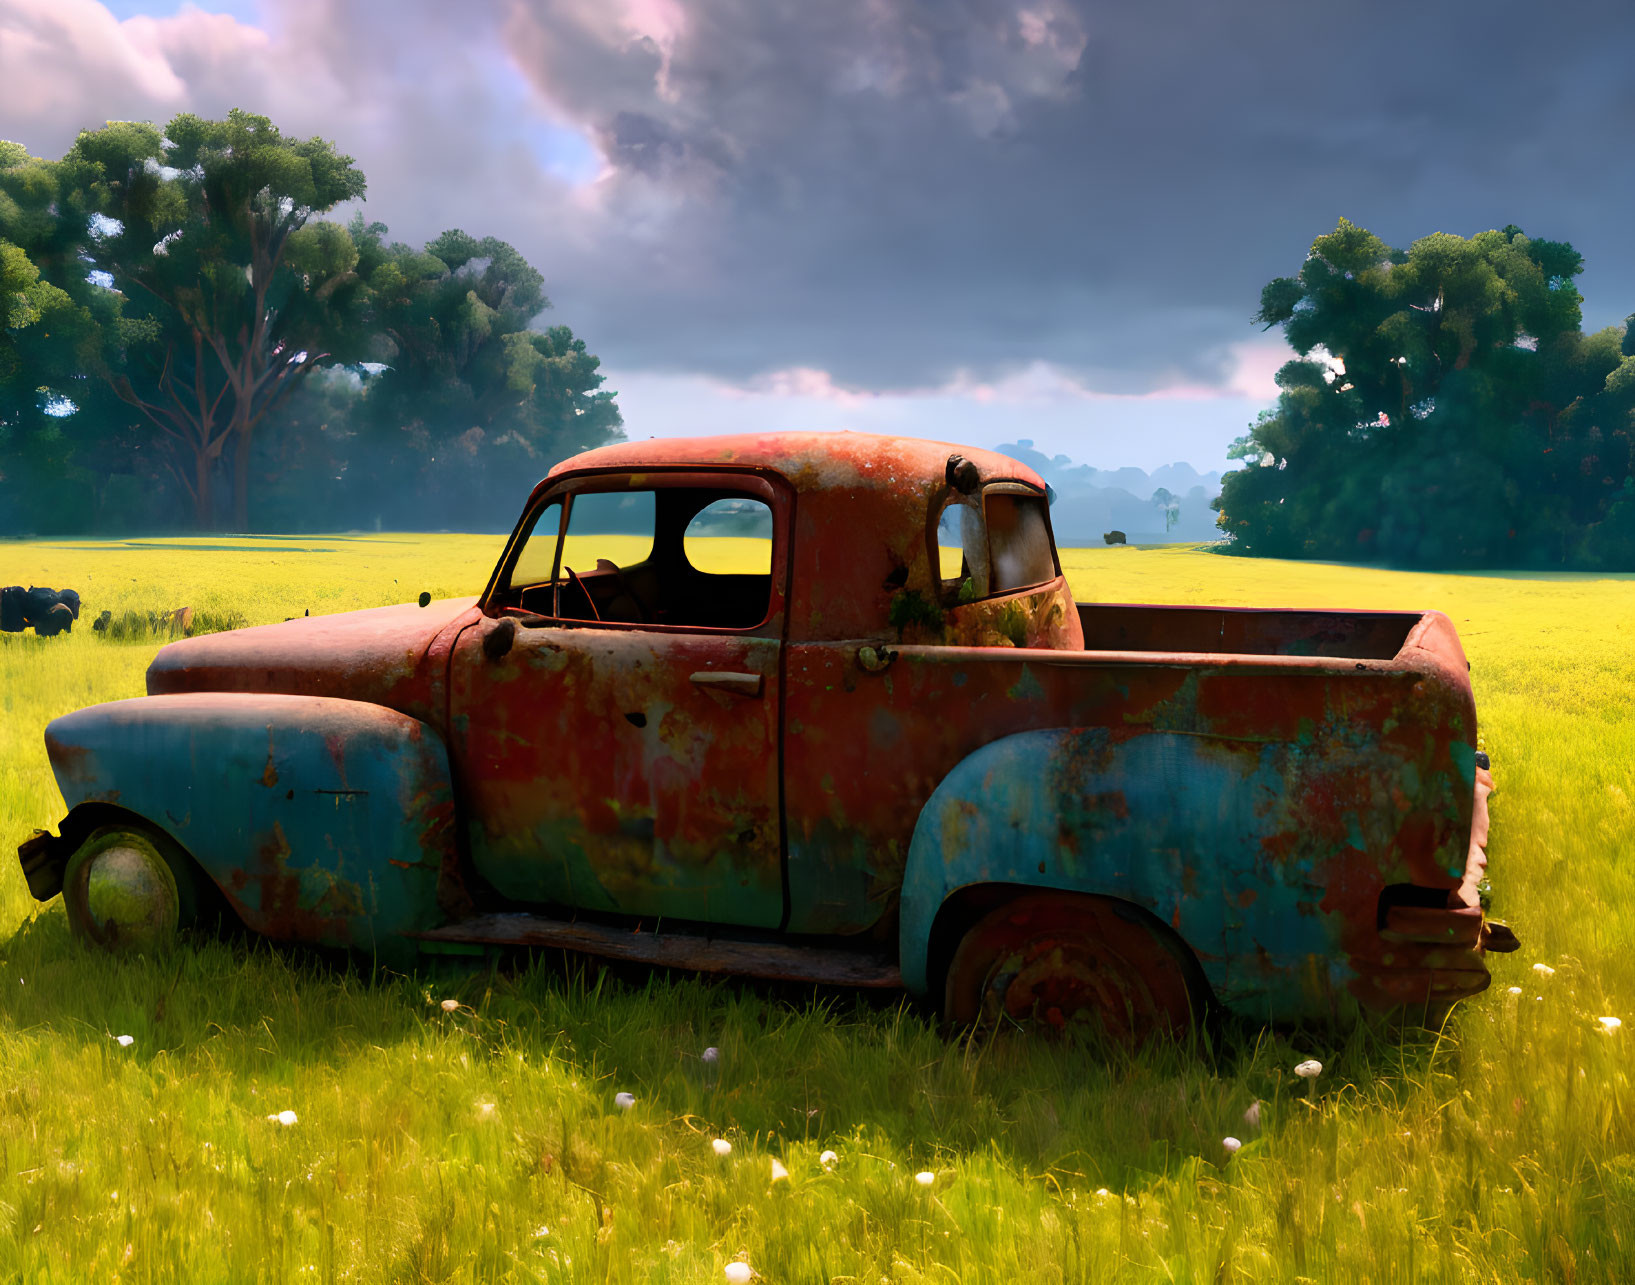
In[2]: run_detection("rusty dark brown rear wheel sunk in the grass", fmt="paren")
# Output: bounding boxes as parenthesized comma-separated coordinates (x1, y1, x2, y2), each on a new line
(943, 893, 1203, 1045)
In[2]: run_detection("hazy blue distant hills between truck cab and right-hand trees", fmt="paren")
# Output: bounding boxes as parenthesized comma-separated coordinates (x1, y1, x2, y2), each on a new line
(994, 438, 1221, 548)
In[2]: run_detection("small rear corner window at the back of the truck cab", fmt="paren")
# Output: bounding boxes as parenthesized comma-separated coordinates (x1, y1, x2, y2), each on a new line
(937, 484, 1056, 602)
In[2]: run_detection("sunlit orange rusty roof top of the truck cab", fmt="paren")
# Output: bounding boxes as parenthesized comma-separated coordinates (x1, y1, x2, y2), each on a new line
(548, 433, 1045, 494)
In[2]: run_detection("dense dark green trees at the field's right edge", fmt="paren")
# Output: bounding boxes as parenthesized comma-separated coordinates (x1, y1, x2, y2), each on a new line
(1215, 219, 1635, 571)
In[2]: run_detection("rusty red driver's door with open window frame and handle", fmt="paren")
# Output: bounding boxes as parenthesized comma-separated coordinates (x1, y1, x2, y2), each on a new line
(450, 471, 786, 927)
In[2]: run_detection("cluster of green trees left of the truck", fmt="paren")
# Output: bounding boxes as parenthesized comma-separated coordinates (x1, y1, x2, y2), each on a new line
(0, 111, 623, 535)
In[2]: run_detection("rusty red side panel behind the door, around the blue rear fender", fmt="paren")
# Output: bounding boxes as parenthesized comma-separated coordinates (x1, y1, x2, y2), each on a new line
(785, 644, 1475, 932)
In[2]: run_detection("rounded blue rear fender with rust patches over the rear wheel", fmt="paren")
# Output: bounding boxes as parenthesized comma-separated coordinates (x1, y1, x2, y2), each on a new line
(901, 728, 1396, 1019)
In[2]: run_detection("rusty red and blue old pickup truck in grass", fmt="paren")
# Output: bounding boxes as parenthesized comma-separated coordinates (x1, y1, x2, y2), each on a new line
(20, 433, 1516, 1037)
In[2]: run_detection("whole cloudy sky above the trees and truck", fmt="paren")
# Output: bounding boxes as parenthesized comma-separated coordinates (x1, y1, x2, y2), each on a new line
(0, 0, 1635, 471)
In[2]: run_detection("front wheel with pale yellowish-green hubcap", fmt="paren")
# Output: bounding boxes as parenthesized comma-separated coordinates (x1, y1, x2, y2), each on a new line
(62, 826, 198, 955)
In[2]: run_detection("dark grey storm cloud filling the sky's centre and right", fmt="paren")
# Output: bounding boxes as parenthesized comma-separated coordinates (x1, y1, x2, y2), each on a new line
(508, 0, 1635, 387)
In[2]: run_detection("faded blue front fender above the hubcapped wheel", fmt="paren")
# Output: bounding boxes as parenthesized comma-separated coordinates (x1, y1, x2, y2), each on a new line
(46, 692, 456, 963)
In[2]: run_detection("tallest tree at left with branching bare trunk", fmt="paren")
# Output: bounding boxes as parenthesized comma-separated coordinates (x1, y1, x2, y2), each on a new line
(57, 110, 365, 530)
